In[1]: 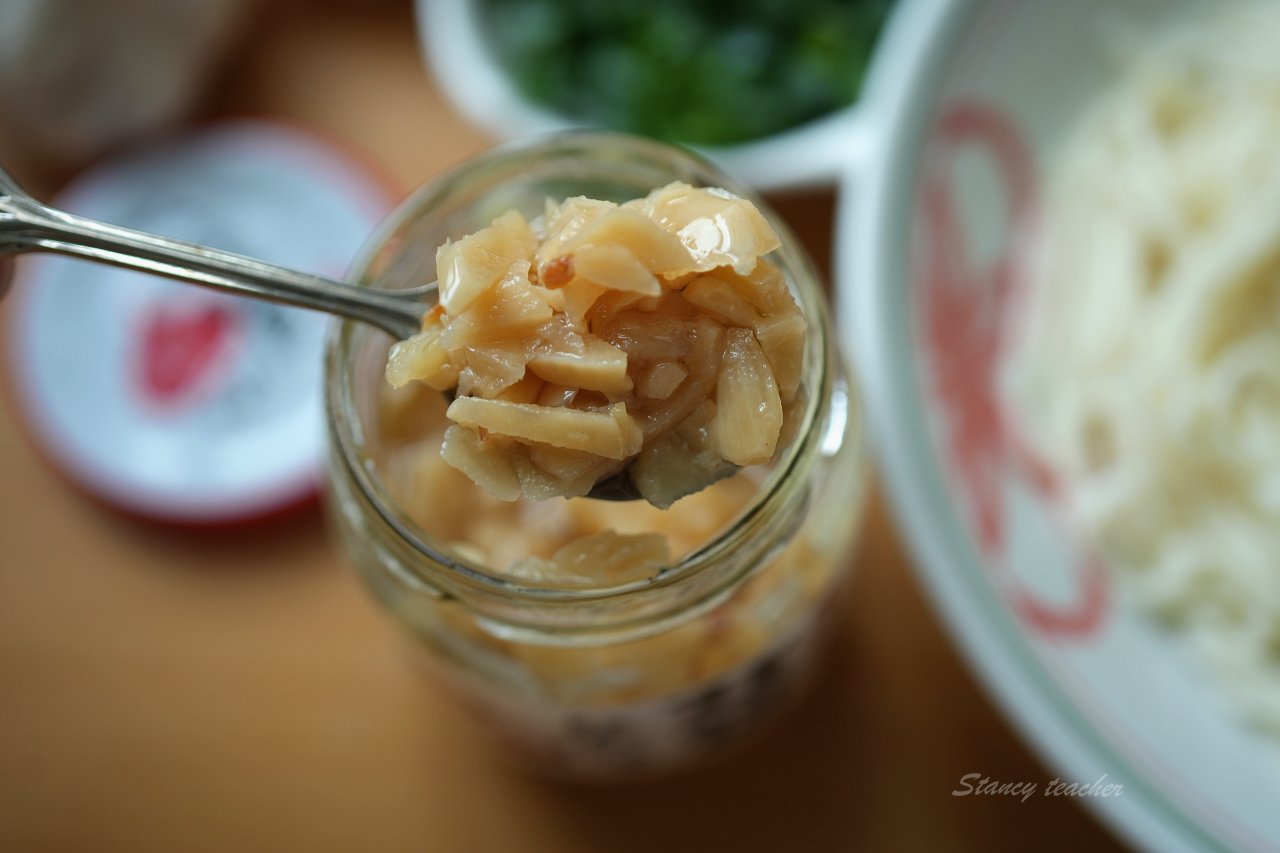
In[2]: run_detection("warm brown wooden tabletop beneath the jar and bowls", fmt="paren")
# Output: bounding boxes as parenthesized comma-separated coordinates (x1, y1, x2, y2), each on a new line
(0, 1, 1116, 853)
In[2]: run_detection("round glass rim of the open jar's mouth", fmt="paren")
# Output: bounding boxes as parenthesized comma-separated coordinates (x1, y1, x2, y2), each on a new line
(325, 131, 836, 605)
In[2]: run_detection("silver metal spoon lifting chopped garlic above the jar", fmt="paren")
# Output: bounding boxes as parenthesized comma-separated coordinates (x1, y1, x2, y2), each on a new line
(0, 169, 650, 501)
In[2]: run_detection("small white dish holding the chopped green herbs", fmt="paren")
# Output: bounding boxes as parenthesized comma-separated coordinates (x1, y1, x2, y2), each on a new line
(417, 0, 870, 191)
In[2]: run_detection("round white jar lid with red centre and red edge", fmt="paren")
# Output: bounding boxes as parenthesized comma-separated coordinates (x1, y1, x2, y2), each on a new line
(10, 122, 390, 525)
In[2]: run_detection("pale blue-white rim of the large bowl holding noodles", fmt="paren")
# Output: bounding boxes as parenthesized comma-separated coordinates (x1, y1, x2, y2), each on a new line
(836, 0, 1225, 850)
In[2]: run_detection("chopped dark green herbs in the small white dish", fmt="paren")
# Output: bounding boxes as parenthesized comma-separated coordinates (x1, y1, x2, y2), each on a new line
(481, 0, 891, 145)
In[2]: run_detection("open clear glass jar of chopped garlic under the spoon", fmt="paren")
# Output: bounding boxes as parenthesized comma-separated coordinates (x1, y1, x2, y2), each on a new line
(326, 133, 867, 777)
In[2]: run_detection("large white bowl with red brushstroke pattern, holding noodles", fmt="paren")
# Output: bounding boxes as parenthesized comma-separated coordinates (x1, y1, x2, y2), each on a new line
(838, 0, 1280, 852)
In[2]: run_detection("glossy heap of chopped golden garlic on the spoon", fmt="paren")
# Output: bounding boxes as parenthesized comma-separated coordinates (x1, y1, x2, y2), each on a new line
(387, 182, 805, 507)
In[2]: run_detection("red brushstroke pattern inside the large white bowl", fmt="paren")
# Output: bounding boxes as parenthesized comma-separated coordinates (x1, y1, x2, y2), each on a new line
(920, 102, 1108, 638)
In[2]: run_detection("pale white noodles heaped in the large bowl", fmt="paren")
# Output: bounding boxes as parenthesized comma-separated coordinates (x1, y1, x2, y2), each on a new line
(1006, 3, 1280, 734)
